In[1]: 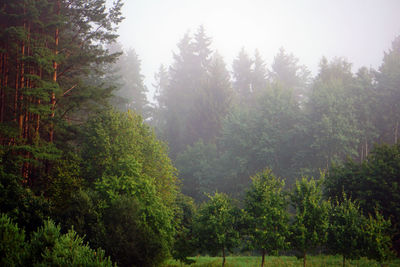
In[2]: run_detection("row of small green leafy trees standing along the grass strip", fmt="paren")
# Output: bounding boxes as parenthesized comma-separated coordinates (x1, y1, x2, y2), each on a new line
(175, 169, 391, 266)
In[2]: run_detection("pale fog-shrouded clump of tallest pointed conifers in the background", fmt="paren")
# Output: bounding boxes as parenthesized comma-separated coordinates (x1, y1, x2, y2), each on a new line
(154, 26, 232, 159)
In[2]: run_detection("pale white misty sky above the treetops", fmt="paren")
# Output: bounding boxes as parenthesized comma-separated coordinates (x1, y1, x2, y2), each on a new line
(115, 0, 400, 90)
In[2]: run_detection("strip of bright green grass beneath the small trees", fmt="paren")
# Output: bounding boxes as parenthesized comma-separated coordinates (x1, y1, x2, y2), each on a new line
(163, 256, 400, 267)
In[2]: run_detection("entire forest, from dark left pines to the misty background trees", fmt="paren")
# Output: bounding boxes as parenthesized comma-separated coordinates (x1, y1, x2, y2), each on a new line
(0, 0, 400, 266)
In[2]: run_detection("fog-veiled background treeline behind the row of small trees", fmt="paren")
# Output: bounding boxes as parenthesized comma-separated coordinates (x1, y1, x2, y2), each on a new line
(151, 27, 400, 202)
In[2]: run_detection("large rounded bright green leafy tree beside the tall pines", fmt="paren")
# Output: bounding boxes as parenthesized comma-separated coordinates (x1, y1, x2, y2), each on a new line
(54, 110, 178, 266)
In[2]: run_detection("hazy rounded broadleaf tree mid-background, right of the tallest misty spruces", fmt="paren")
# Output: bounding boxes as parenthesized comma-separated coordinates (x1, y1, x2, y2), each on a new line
(219, 81, 303, 193)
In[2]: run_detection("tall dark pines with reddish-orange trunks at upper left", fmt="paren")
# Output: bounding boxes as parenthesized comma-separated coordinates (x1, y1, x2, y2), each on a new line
(0, 0, 122, 185)
